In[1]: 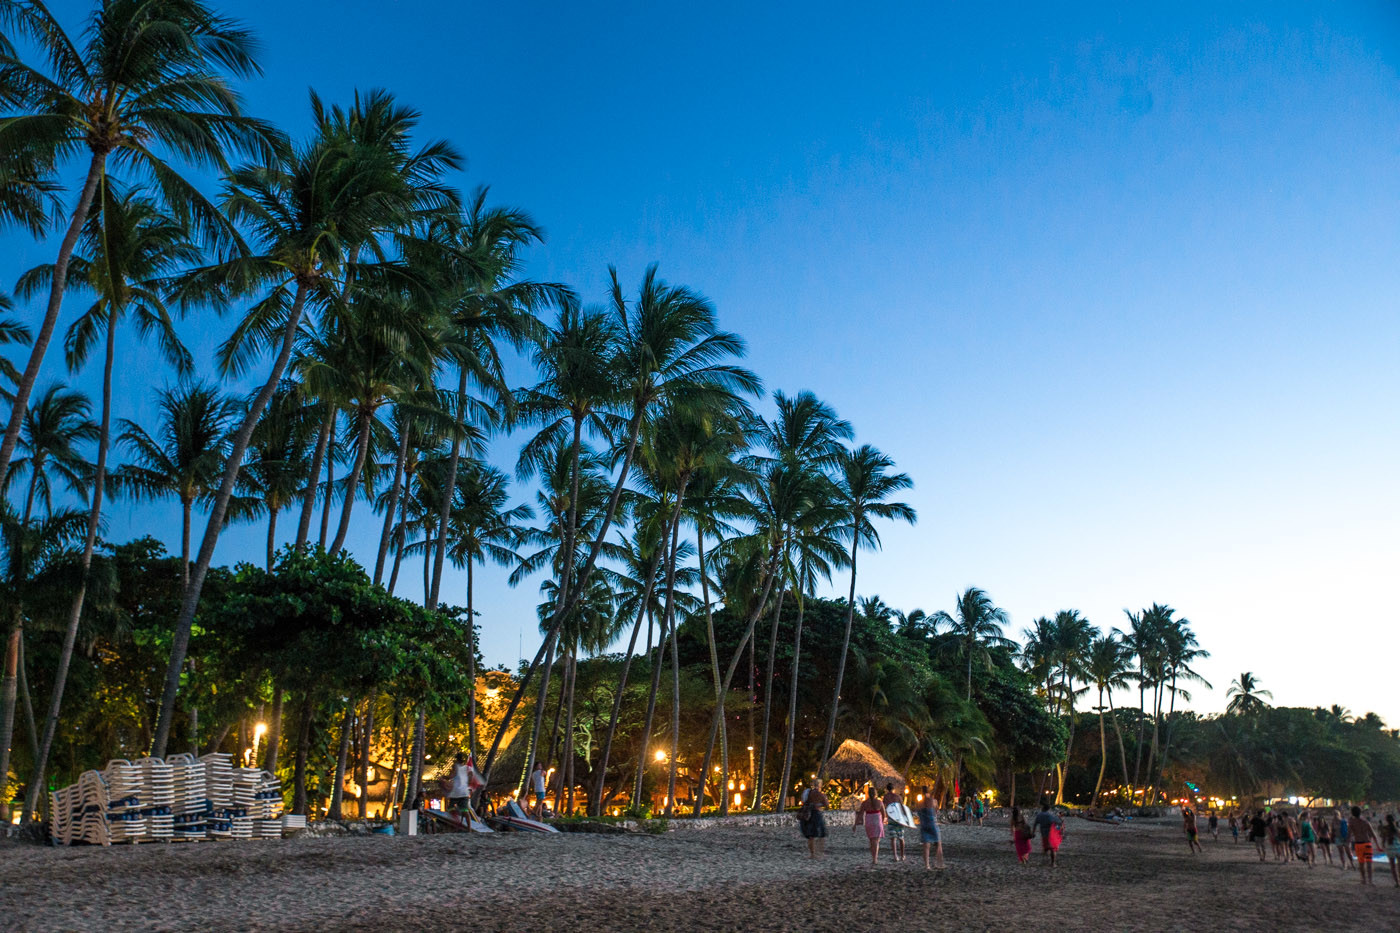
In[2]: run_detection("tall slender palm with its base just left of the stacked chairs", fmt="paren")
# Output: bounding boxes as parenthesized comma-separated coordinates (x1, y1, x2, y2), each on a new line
(21, 177, 200, 813)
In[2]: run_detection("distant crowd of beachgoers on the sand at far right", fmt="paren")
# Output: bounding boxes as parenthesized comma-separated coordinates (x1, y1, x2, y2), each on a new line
(1182, 807, 1400, 887)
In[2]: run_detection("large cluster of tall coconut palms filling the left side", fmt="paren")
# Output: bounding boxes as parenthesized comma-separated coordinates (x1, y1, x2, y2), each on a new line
(0, 0, 914, 815)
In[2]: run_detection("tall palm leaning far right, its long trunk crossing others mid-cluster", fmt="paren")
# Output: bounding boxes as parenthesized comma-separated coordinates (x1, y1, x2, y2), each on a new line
(483, 266, 762, 780)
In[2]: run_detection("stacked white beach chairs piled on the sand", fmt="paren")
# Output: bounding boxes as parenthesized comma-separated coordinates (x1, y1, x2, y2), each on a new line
(49, 752, 294, 846)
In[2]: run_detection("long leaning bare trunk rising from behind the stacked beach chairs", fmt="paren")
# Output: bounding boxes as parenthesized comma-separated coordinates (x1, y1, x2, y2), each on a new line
(151, 283, 307, 758)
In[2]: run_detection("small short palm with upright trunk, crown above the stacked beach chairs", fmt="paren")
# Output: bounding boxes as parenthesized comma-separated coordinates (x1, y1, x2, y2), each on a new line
(112, 381, 242, 587)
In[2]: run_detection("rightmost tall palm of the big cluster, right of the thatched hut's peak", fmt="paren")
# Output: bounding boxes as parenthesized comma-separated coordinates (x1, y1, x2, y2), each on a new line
(822, 444, 917, 770)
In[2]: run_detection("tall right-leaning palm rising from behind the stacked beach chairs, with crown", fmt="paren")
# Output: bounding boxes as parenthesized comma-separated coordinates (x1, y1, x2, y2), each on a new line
(153, 95, 442, 756)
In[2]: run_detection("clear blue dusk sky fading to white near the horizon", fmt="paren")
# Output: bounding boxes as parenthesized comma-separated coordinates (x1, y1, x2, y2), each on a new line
(4, 0, 1400, 724)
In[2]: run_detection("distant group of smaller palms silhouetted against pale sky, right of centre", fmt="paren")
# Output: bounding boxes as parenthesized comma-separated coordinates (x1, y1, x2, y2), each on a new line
(1021, 602, 1210, 803)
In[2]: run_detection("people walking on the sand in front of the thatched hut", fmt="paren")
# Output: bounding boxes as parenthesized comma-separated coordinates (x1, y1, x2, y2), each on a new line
(797, 778, 1064, 870)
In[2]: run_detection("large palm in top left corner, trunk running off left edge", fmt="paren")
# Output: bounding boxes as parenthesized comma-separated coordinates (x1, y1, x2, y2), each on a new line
(0, 0, 279, 488)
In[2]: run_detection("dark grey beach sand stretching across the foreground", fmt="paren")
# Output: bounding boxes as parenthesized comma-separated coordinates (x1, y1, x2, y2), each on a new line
(0, 814, 1400, 933)
